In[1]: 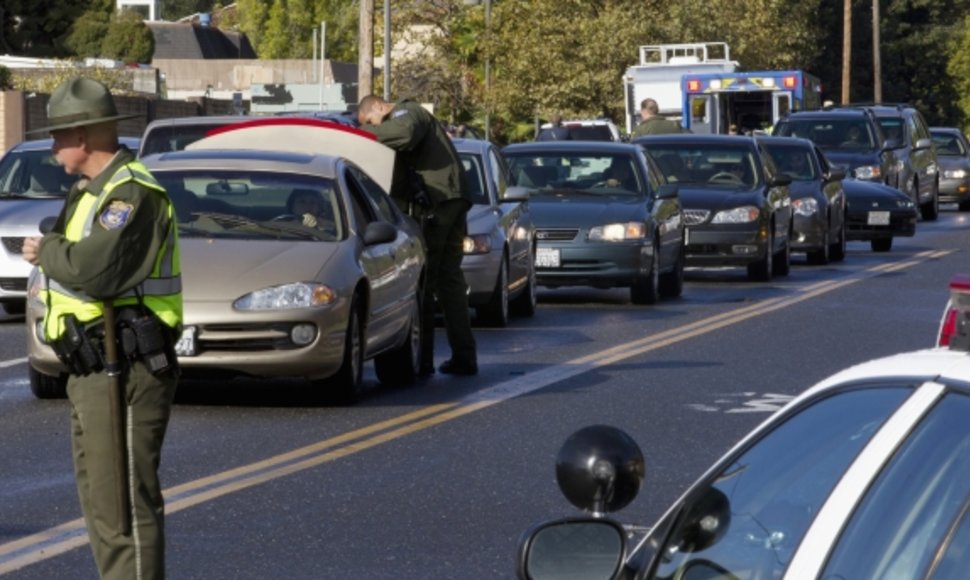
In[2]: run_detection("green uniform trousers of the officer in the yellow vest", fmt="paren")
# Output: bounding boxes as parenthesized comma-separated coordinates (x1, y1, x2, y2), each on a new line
(67, 362, 178, 580)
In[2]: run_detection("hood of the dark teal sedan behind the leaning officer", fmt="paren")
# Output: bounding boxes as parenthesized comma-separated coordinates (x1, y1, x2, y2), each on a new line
(529, 190, 646, 228)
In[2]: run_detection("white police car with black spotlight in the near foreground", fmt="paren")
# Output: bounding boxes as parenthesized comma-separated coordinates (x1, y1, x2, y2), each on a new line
(517, 343, 970, 580)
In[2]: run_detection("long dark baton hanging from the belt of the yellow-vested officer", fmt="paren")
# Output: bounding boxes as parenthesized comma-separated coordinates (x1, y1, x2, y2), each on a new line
(104, 302, 131, 536)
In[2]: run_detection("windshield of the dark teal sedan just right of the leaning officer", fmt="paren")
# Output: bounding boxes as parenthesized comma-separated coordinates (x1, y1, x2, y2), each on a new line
(508, 151, 645, 196)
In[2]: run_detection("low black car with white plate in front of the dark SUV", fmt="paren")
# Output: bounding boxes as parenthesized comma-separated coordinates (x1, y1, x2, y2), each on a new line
(842, 179, 919, 252)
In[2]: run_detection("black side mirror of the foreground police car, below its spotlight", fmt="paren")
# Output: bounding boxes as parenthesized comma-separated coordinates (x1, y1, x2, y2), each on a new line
(516, 518, 626, 580)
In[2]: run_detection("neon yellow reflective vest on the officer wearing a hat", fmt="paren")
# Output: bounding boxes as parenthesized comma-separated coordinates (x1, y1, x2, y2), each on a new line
(40, 161, 182, 341)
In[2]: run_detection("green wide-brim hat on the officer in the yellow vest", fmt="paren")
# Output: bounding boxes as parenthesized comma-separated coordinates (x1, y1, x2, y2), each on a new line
(27, 77, 139, 134)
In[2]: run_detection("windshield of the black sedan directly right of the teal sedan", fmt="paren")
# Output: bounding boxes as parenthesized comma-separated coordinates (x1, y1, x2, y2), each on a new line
(646, 142, 760, 191)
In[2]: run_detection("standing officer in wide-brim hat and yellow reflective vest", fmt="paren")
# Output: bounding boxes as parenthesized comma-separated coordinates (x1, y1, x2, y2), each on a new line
(23, 78, 182, 580)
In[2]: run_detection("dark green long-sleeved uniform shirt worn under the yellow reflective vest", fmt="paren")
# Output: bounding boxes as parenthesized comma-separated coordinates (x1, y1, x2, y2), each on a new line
(39, 146, 169, 299)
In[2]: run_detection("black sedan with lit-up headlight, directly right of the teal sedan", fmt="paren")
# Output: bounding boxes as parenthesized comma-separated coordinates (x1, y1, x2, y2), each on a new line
(634, 134, 792, 281)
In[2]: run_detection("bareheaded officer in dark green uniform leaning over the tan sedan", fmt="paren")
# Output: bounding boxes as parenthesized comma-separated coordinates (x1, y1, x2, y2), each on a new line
(357, 95, 478, 376)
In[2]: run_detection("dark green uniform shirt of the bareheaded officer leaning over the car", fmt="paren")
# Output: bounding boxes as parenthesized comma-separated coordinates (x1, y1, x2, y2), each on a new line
(363, 99, 468, 208)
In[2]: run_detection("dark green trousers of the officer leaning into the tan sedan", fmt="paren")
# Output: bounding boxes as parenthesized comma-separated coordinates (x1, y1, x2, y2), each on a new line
(421, 199, 478, 367)
